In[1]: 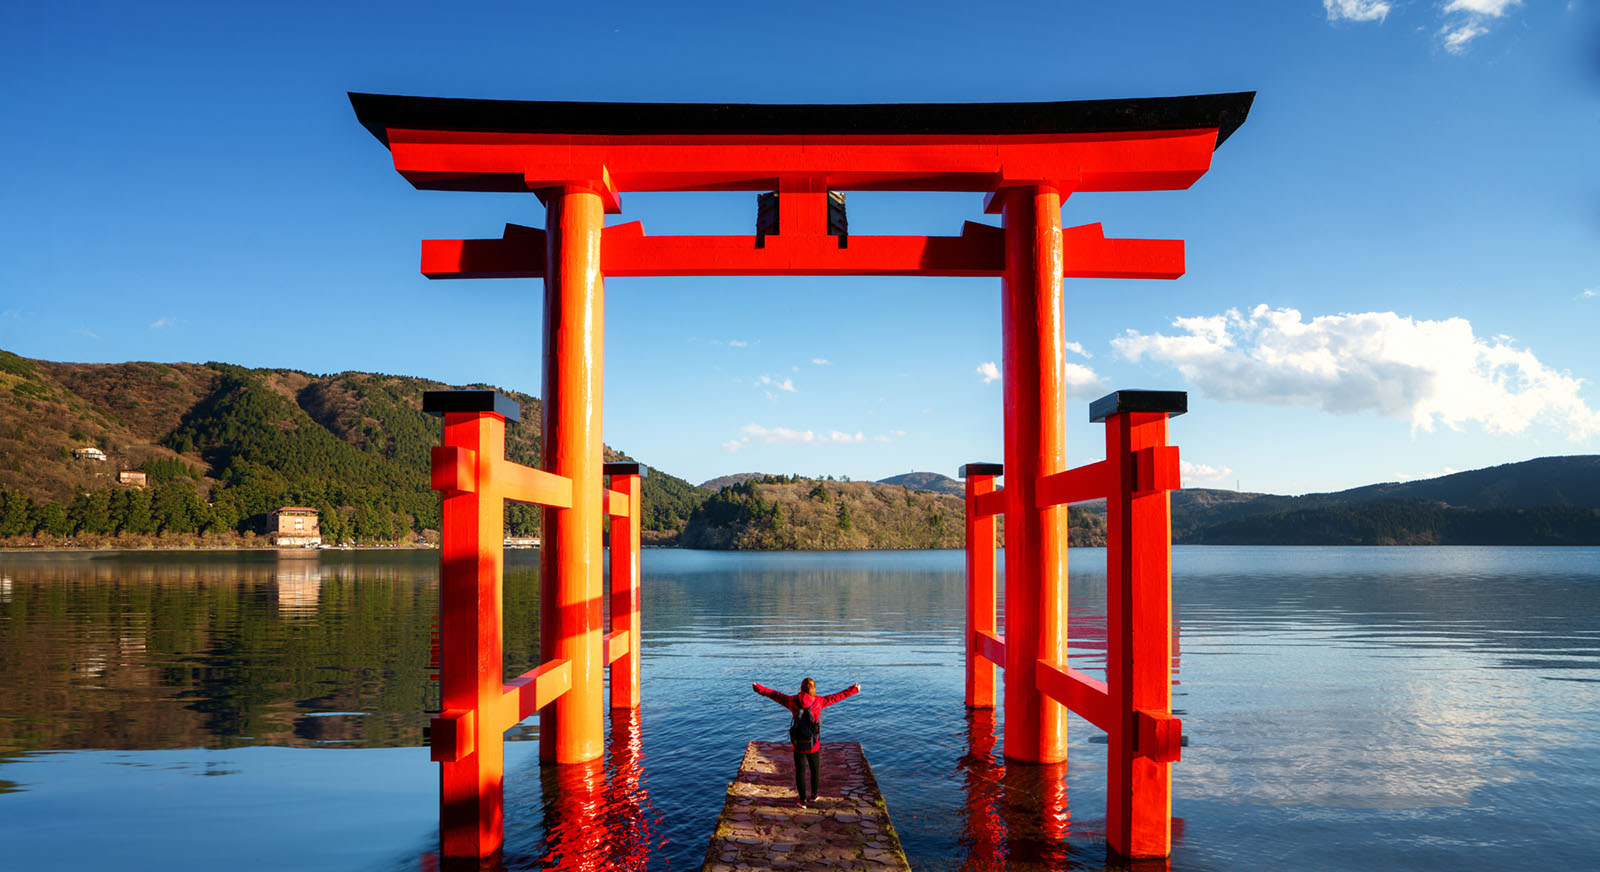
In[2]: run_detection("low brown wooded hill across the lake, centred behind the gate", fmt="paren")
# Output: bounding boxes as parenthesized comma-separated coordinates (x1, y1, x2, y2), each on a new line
(678, 475, 1106, 550)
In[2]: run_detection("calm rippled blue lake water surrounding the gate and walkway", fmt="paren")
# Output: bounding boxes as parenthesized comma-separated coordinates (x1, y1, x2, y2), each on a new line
(0, 547, 1600, 872)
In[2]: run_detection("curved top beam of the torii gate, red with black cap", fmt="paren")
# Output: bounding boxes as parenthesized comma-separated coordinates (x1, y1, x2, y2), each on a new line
(350, 93, 1254, 203)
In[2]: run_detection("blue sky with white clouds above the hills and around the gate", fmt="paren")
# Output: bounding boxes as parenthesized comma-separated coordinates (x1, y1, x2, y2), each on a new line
(0, 0, 1600, 493)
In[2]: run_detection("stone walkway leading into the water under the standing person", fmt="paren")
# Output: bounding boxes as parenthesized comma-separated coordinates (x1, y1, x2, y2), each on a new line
(702, 742, 910, 872)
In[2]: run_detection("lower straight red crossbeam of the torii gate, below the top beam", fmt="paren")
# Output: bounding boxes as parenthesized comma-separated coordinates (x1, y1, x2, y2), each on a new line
(422, 221, 1184, 278)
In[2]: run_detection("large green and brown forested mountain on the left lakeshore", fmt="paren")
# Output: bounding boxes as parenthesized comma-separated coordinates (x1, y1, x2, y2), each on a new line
(0, 352, 702, 541)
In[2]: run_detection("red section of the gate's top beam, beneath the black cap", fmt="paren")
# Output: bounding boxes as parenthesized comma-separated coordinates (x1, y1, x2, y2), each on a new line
(387, 128, 1218, 195)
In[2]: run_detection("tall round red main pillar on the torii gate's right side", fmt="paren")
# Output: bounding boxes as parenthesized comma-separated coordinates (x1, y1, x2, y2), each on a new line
(990, 184, 1067, 763)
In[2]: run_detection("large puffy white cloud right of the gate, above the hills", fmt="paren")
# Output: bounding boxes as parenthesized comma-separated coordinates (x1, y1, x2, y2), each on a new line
(1112, 304, 1600, 440)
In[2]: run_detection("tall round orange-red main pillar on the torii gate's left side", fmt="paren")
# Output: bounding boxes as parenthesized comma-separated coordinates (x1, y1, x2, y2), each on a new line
(539, 182, 606, 763)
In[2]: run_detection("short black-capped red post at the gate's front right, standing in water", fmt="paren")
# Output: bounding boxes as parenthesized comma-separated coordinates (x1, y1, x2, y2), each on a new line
(1090, 390, 1187, 858)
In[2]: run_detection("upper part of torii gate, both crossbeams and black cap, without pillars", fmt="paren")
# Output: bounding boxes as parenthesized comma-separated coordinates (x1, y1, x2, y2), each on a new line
(350, 93, 1254, 278)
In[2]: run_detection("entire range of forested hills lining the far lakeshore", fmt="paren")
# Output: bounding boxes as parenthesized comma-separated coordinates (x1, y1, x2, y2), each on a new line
(0, 352, 1600, 549)
